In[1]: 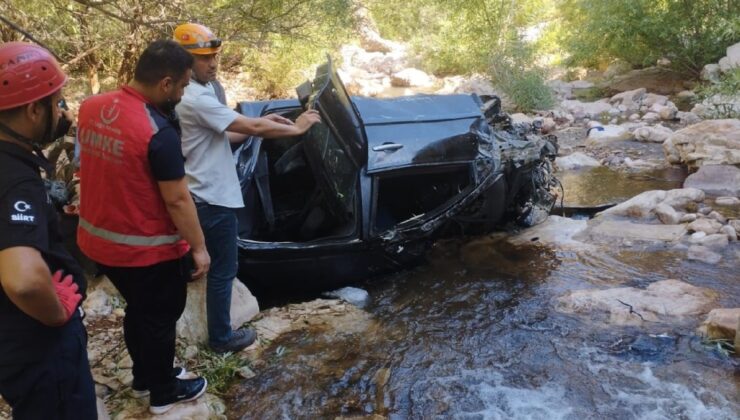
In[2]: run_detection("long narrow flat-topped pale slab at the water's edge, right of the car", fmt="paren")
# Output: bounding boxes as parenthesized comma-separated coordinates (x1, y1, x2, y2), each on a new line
(587, 220, 686, 242)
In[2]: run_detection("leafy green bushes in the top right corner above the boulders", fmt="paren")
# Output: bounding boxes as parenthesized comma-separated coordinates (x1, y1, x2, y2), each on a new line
(552, 0, 740, 74)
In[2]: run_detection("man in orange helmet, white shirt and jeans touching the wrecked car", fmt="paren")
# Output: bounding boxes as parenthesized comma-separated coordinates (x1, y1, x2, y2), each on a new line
(174, 23, 320, 353)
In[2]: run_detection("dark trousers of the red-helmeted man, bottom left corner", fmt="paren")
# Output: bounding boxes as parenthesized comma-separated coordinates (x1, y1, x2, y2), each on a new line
(0, 315, 98, 420)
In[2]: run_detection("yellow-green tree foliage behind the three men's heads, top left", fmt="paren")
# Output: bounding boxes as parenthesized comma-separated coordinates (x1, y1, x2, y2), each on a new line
(0, 0, 352, 96)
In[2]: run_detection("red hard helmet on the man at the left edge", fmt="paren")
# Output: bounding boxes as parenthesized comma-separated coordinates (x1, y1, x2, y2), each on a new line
(0, 42, 67, 111)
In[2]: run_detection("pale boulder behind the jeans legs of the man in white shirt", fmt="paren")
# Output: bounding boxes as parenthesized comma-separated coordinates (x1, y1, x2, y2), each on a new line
(177, 279, 259, 344)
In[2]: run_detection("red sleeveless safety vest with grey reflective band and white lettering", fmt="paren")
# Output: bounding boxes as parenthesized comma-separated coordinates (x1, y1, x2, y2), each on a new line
(77, 87, 189, 267)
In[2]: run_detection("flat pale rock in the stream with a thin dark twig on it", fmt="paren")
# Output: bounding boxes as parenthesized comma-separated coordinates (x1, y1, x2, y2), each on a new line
(556, 280, 718, 325)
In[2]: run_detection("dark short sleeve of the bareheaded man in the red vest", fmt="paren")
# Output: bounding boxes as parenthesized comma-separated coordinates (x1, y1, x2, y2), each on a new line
(149, 127, 185, 181)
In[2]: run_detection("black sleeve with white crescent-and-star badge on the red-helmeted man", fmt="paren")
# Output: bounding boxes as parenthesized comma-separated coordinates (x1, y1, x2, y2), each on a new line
(0, 180, 49, 252)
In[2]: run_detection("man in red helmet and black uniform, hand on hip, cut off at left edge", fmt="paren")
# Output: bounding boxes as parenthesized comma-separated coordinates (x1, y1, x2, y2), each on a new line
(0, 42, 97, 420)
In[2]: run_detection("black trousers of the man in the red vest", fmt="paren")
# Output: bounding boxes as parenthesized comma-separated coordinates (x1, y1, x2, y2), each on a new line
(99, 259, 189, 393)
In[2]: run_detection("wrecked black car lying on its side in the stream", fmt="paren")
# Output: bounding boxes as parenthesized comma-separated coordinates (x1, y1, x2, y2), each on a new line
(234, 60, 557, 294)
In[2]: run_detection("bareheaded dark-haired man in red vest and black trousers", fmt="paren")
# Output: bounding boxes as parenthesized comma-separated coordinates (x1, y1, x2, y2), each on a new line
(77, 41, 210, 414)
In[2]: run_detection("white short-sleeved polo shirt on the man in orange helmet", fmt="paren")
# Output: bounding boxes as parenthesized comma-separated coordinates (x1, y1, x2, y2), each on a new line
(175, 80, 244, 208)
